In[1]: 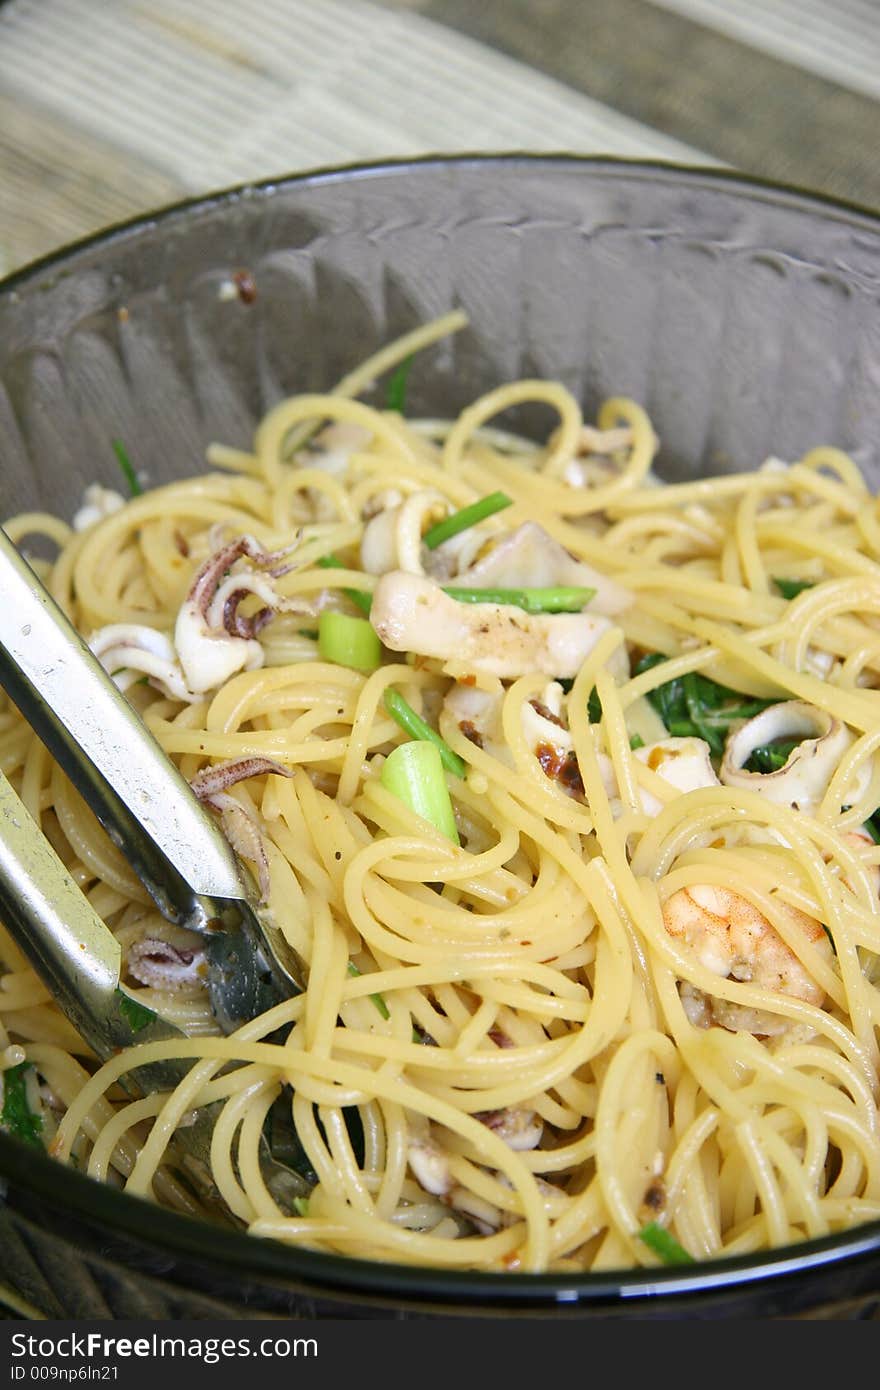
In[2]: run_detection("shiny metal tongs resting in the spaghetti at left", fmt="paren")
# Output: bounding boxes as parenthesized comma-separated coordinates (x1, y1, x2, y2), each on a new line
(0, 528, 306, 1217)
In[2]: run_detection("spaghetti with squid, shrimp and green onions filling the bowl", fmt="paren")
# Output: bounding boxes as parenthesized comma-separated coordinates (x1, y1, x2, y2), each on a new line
(0, 314, 880, 1277)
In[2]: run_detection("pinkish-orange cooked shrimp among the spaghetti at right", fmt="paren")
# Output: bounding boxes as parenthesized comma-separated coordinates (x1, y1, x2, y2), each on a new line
(663, 884, 831, 1036)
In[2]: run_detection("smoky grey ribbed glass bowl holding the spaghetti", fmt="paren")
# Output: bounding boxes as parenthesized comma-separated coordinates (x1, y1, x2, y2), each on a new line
(0, 156, 880, 1318)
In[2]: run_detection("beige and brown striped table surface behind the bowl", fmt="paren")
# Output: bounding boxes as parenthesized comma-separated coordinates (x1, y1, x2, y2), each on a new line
(0, 0, 880, 272)
